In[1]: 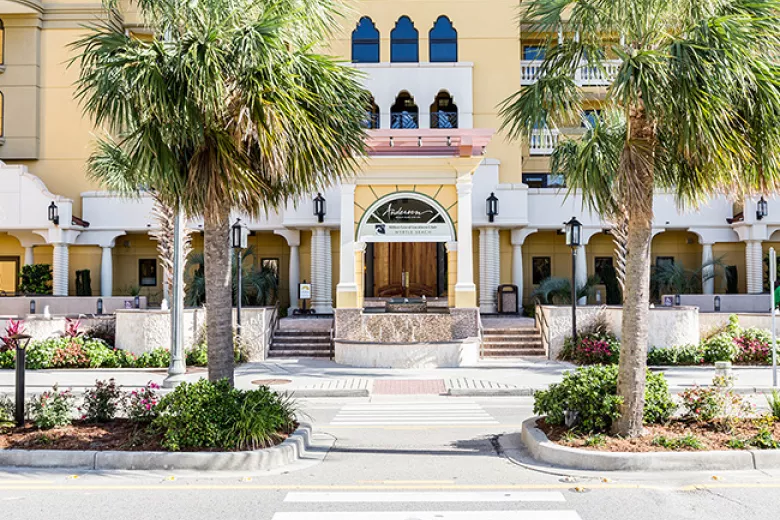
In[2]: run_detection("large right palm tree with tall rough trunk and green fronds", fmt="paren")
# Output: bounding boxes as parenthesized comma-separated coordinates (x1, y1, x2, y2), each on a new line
(501, 0, 780, 436)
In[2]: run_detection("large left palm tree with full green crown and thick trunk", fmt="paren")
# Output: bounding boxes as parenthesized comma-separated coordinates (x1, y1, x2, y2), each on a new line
(74, 0, 368, 382)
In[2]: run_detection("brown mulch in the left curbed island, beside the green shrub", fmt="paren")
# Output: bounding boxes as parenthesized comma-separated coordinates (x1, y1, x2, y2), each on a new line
(0, 419, 287, 452)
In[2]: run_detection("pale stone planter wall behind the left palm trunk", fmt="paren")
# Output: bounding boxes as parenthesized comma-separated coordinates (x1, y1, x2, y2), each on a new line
(116, 307, 276, 361)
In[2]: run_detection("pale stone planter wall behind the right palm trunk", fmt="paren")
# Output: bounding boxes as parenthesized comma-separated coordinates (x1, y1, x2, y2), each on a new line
(537, 305, 699, 359)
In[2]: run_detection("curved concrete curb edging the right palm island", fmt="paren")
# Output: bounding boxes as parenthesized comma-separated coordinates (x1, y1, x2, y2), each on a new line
(521, 417, 780, 471)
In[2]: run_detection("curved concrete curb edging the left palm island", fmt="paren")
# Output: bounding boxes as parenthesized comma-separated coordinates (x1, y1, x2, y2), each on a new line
(0, 423, 311, 471)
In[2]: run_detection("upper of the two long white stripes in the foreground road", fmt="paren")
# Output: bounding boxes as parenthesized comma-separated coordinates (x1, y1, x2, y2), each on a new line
(284, 491, 566, 503)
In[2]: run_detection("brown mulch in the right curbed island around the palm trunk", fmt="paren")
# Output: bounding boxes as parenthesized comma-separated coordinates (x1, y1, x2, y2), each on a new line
(537, 419, 780, 453)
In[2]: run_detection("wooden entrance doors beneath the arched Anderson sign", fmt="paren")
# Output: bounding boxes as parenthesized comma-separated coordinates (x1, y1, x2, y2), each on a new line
(357, 192, 455, 298)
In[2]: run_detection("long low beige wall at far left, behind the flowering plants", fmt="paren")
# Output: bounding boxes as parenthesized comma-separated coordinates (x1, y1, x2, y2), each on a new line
(0, 295, 147, 318)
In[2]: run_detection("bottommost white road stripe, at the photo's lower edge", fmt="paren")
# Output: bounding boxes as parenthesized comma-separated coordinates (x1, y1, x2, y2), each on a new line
(273, 511, 582, 520)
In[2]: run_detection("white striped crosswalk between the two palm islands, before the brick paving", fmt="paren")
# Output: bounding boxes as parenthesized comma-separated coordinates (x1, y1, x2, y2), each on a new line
(330, 402, 498, 426)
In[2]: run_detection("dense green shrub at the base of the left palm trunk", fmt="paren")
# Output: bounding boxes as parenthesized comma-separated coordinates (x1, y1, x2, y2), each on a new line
(152, 379, 295, 451)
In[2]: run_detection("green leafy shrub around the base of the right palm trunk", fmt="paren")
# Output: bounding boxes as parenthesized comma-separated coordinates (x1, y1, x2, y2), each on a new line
(534, 365, 675, 432)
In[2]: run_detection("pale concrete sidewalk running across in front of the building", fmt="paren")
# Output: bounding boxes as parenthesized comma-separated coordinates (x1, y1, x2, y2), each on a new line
(0, 359, 772, 398)
